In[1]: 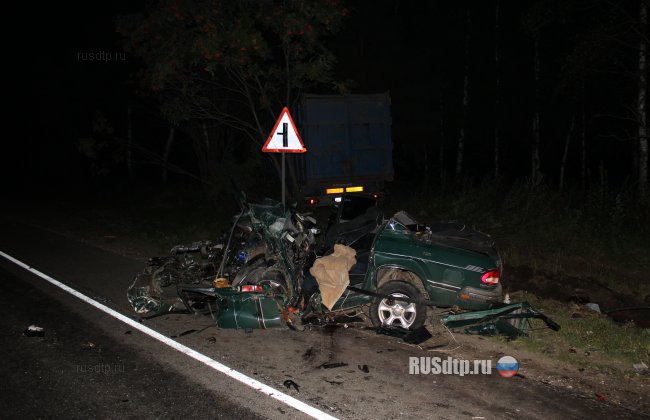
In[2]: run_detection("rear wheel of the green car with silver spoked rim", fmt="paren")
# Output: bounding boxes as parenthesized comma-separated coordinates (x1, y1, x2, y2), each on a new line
(370, 281, 427, 330)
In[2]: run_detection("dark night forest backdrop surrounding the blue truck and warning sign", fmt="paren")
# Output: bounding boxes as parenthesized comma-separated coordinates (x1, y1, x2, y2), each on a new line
(3, 0, 648, 210)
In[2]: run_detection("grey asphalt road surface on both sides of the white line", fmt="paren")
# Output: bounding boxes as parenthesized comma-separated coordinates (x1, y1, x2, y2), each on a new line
(0, 219, 641, 419)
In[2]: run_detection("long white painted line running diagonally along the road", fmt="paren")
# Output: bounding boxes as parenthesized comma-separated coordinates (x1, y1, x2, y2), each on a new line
(0, 251, 336, 419)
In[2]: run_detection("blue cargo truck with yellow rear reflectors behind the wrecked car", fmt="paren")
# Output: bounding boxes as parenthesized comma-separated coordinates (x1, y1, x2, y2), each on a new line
(294, 92, 393, 206)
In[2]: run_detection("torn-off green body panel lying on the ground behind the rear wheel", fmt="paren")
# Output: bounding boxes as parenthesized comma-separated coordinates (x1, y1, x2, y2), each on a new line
(441, 302, 560, 337)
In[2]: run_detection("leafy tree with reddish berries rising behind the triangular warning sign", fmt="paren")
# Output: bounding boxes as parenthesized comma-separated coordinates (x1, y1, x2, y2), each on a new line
(117, 0, 348, 195)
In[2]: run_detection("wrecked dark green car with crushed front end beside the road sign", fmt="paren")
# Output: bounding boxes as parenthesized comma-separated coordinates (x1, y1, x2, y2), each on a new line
(127, 195, 520, 330)
